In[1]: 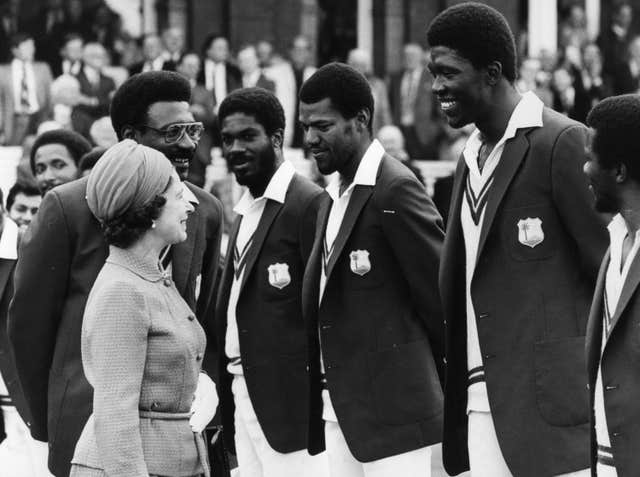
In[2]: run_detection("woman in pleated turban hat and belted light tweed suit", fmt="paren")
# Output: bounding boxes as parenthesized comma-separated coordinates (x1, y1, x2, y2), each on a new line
(71, 140, 217, 477)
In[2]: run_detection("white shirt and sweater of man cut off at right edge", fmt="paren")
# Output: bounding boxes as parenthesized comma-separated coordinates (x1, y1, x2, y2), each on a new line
(594, 214, 640, 477)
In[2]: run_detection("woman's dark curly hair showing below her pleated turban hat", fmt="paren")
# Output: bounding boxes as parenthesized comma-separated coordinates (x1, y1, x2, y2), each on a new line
(102, 195, 167, 248)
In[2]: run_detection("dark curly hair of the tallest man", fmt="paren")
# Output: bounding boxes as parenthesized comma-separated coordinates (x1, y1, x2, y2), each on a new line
(427, 2, 517, 83)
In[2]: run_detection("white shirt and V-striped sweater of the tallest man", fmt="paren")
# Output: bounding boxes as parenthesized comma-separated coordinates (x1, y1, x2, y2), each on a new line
(460, 92, 544, 412)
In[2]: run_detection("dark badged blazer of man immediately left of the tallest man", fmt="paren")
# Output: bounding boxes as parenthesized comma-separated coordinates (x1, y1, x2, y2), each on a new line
(302, 154, 444, 462)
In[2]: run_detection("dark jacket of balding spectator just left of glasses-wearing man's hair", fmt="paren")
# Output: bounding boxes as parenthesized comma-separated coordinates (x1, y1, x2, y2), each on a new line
(71, 69, 116, 137)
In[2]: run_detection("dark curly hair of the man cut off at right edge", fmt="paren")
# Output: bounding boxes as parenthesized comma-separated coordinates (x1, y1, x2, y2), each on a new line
(587, 94, 640, 181)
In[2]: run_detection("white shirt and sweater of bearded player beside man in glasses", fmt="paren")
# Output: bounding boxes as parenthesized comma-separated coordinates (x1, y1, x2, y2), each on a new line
(224, 161, 296, 375)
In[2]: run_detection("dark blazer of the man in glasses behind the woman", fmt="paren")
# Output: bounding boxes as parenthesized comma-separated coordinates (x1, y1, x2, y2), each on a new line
(9, 178, 222, 476)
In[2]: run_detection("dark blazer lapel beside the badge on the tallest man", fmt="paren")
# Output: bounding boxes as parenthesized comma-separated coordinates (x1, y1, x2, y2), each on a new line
(476, 130, 529, 263)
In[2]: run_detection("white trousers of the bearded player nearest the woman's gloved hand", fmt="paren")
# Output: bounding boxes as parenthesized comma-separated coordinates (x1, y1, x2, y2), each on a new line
(231, 376, 329, 477)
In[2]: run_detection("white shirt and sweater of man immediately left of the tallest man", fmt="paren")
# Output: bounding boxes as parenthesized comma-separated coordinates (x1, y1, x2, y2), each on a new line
(319, 139, 384, 422)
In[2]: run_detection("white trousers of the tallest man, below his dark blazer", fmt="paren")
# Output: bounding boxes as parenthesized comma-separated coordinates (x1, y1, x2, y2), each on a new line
(468, 411, 591, 477)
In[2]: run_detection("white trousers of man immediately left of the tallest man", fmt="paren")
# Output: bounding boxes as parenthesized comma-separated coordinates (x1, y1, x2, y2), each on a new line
(324, 421, 431, 477)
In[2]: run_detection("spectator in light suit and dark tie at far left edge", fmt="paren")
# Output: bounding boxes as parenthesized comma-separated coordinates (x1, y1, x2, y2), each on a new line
(0, 33, 52, 145)
